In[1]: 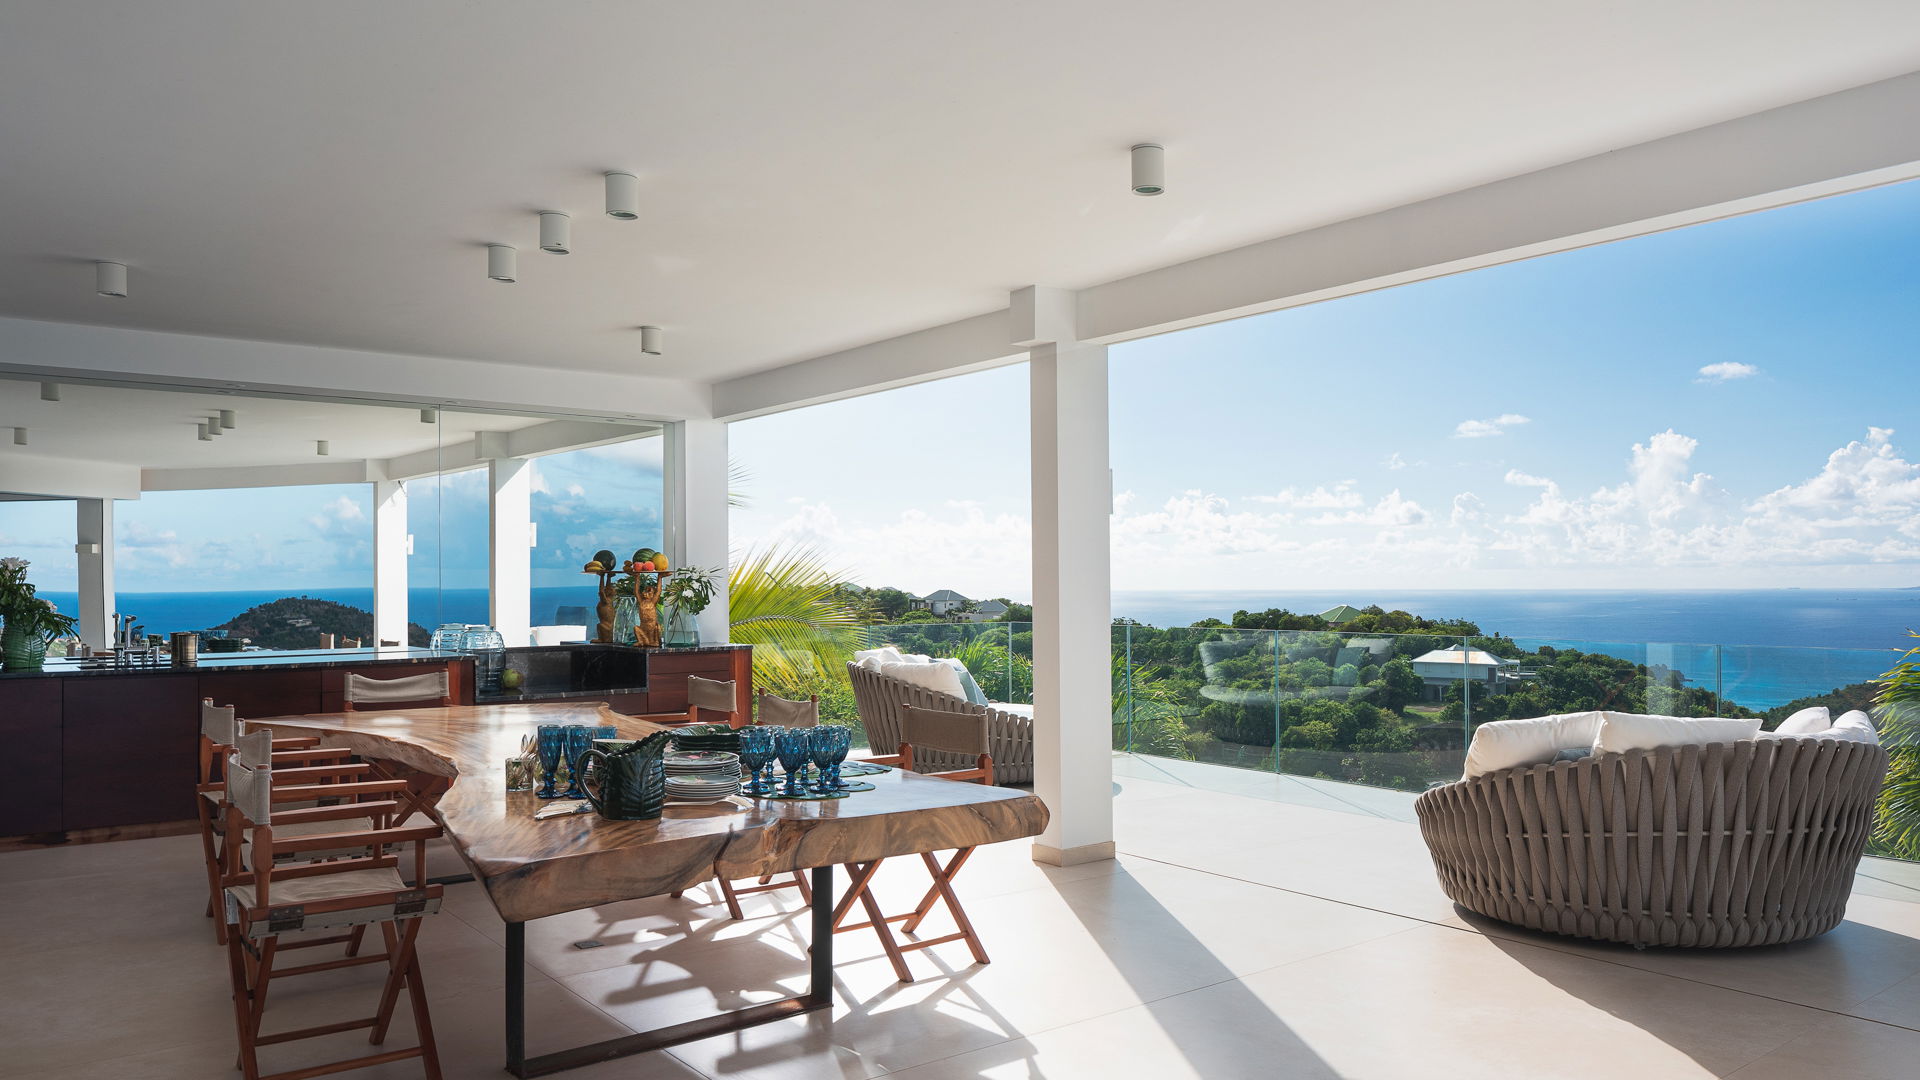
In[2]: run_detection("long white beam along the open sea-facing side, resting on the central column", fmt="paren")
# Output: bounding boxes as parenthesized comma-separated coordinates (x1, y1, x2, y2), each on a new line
(712, 73, 1920, 419)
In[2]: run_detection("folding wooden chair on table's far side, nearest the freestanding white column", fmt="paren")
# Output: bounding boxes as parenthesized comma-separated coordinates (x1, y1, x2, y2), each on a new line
(833, 705, 993, 982)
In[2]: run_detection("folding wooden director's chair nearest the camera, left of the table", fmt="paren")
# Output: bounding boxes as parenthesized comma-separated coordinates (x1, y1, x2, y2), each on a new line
(221, 732, 442, 1080)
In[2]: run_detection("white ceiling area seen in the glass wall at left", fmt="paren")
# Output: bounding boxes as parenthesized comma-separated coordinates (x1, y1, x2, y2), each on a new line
(0, 379, 583, 469)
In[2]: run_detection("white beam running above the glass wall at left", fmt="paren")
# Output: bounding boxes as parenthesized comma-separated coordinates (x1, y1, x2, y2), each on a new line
(0, 319, 712, 421)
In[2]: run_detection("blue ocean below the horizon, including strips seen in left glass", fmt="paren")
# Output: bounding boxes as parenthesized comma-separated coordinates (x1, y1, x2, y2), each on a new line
(33, 584, 1920, 709)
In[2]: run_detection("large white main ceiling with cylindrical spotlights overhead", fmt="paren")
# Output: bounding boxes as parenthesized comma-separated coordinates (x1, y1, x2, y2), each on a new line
(0, 0, 1920, 380)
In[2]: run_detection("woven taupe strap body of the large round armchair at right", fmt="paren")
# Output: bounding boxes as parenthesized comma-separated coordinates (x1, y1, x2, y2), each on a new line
(1413, 738, 1887, 947)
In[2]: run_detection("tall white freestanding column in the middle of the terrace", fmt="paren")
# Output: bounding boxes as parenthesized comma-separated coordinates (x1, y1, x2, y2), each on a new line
(1012, 288, 1114, 867)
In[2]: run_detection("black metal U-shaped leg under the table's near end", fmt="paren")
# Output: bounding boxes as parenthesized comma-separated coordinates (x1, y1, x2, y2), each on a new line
(507, 867, 833, 1080)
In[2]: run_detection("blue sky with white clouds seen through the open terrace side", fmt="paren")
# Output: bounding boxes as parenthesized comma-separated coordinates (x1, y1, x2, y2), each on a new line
(732, 183, 1920, 596)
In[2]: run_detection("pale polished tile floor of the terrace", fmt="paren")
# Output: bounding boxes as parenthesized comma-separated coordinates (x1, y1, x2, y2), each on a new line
(0, 757, 1920, 1080)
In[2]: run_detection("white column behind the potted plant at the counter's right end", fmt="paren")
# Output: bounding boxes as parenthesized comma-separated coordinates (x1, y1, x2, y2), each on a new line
(664, 421, 732, 642)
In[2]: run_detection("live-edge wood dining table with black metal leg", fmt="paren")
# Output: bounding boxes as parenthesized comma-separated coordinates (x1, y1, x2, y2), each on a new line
(250, 703, 1046, 1076)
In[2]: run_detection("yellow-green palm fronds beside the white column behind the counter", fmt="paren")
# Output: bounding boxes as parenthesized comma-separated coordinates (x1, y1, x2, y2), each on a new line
(728, 544, 858, 696)
